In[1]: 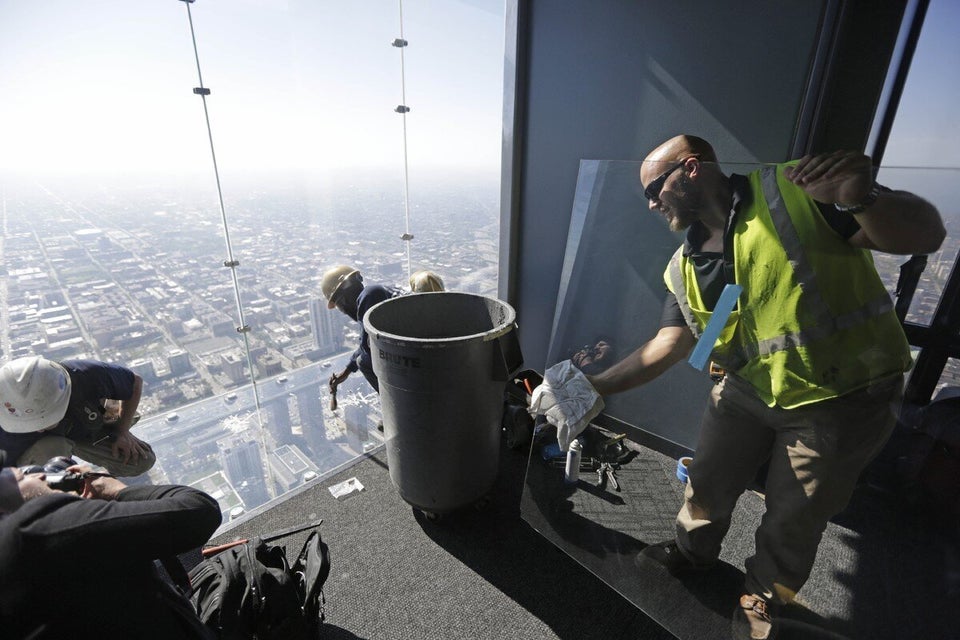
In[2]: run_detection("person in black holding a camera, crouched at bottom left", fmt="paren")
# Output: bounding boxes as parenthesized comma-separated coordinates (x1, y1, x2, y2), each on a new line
(0, 461, 221, 640)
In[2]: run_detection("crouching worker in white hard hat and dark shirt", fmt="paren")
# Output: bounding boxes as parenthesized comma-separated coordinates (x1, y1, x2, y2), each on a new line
(0, 356, 156, 477)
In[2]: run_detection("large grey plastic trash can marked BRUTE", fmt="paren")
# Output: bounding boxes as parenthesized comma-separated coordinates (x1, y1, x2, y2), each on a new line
(363, 292, 523, 514)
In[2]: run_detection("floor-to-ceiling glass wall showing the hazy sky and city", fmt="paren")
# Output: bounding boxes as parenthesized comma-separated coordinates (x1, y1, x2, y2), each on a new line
(0, 0, 503, 516)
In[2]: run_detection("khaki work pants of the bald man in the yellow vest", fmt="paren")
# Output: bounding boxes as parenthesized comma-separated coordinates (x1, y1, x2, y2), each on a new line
(677, 375, 903, 603)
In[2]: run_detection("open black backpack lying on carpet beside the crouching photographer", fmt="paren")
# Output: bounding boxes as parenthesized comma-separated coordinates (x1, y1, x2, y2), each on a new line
(189, 531, 330, 640)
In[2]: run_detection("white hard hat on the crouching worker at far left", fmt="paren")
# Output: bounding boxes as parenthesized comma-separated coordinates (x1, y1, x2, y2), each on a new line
(0, 356, 70, 433)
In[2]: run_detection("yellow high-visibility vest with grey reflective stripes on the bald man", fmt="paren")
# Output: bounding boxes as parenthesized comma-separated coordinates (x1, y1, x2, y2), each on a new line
(664, 165, 911, 409)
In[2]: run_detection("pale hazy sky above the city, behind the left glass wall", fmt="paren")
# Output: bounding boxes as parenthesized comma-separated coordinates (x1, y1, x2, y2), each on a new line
(0, 0, 504, 175)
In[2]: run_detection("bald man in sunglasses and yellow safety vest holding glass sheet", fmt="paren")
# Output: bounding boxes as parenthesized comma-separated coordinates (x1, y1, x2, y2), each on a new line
(589, 135, 945, 640)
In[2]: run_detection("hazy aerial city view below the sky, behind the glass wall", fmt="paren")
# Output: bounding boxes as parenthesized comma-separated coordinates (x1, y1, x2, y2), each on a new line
(0, 178, 499, 517)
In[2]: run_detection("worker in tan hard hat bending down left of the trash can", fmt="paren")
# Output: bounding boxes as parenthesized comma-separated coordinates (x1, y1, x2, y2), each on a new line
(320, 264, 403, 397)
